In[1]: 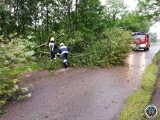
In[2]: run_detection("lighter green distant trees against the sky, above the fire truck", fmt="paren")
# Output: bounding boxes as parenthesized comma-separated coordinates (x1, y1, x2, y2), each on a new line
(104, 0, 150, 32)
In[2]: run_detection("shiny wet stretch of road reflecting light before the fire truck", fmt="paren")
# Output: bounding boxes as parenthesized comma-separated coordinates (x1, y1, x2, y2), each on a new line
(126, 44, 160, 87)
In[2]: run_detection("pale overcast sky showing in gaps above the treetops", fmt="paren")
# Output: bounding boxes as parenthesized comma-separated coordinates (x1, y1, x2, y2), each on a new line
(100, 0, 160, 38)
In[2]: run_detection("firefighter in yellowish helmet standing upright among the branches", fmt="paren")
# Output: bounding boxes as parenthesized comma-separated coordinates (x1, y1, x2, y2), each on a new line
(49, 36, 57, 60)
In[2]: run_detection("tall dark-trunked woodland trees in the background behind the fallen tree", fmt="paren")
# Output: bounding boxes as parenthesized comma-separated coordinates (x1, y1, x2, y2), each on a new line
(0, 0, 159, 40)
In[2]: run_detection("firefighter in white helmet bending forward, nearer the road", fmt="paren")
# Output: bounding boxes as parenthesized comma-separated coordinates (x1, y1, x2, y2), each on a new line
(57, 43, 69, 68)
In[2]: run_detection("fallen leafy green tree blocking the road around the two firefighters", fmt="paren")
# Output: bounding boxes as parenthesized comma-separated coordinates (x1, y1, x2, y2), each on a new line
(38, 28, 133, 69)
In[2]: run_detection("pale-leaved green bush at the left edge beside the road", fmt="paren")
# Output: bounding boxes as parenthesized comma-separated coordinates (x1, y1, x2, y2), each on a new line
(0, 38, 36, 113)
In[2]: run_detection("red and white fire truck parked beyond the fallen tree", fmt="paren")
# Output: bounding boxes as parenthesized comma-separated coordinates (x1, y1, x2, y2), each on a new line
(132, 32, 150, 51)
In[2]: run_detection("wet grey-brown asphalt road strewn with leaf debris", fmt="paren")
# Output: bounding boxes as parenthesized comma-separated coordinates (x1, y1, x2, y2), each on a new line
(0, 45, 160, 120)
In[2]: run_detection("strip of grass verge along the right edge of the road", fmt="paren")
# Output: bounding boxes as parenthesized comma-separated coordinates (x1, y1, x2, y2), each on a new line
(119, 52, 160, 120)
